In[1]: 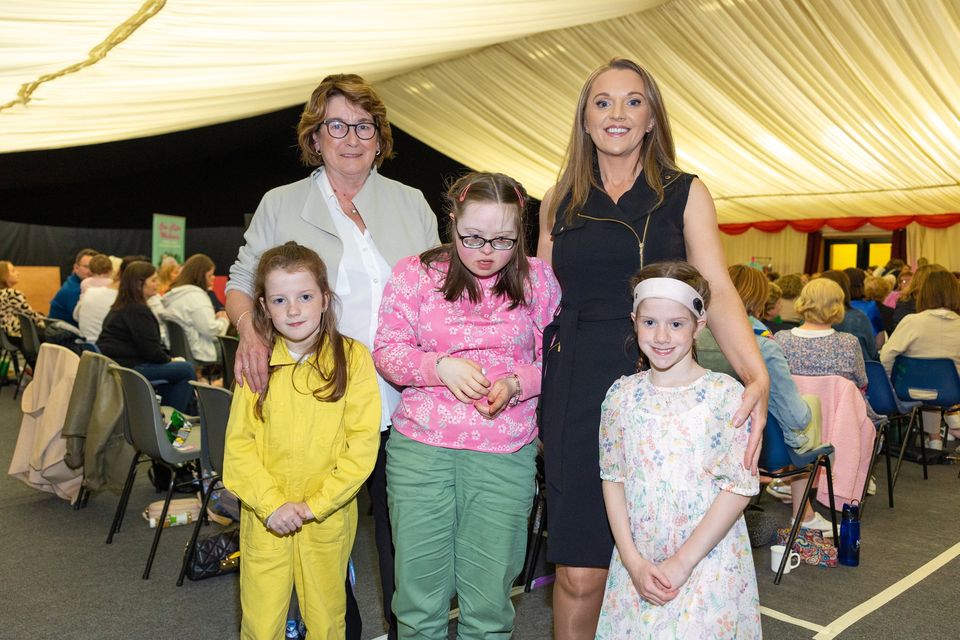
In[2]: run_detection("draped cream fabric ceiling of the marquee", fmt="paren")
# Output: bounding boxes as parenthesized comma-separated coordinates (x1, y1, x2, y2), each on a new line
(0, 0, 960, 223)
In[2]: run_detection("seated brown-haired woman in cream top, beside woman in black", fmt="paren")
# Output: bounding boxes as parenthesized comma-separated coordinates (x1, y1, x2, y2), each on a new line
(163, 253, 230, 362)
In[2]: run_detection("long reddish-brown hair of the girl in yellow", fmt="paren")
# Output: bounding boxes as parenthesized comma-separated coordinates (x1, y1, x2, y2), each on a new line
(251, 241, 353, 420)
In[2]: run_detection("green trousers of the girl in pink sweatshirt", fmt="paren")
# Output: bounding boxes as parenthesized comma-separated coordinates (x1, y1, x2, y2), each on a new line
(387, 431, 537, 640)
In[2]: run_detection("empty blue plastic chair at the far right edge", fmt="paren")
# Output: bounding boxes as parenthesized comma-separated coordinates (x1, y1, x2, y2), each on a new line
(890, 355, 960, 452)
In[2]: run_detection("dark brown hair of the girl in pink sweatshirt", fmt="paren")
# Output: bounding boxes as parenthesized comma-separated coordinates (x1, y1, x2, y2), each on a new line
(420, 172, 530, 309)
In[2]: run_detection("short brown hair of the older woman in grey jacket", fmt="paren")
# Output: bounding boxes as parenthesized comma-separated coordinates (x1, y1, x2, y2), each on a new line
(297, 73, 393, 167)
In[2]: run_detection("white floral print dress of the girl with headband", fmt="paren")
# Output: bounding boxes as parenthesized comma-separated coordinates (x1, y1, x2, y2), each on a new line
(597, 371, 761, 640)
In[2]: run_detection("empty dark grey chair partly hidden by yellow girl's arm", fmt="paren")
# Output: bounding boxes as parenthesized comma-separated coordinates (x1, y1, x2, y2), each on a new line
(177, 380, 233, 587)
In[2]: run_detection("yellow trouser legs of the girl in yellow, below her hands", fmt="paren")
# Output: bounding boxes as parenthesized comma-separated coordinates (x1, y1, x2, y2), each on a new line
(240, 499, 357, 640)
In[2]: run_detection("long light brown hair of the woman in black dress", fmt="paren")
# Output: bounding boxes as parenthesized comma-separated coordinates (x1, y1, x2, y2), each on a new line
(544, 58, 680, 226)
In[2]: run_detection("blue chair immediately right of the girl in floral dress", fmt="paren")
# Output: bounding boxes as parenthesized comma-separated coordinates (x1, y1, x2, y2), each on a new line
(759, 413, 840, 584)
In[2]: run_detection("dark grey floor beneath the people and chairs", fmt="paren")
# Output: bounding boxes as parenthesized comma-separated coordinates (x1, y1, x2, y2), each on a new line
(0, 378, 960, 640)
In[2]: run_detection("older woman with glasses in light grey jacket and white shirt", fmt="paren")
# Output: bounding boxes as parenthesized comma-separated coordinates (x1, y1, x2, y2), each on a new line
(226, 74, 440, 637)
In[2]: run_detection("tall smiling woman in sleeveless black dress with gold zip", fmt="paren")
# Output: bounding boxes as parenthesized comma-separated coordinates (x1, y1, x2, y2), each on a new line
(537, 59, 770, 639)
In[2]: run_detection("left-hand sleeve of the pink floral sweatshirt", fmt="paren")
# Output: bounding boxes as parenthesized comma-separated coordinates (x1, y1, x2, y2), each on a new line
(373, 256, 444, 387)
